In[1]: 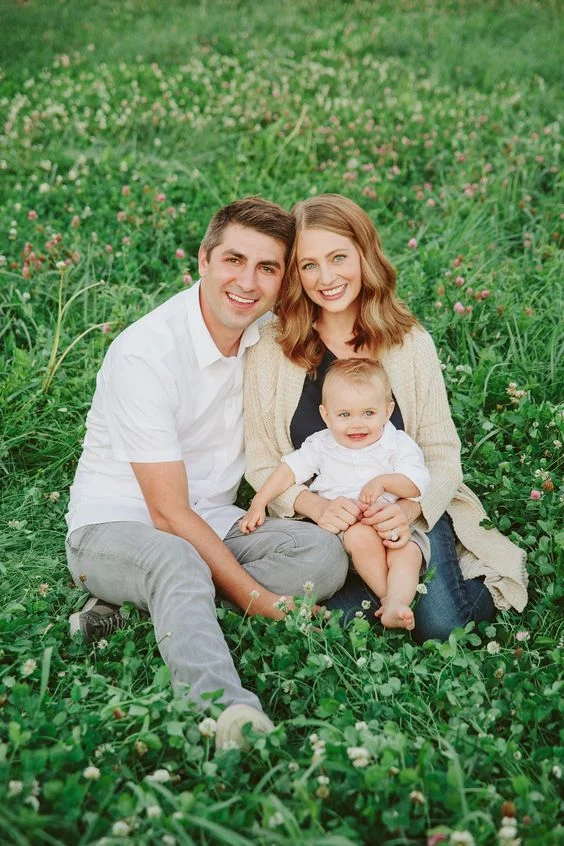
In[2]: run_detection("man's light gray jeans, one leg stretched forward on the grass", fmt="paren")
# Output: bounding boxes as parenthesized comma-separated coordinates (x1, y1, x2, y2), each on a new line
(66, 518, 348, 709)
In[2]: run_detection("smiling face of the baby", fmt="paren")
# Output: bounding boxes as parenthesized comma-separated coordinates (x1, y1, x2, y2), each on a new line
(319, 377, 394, 449)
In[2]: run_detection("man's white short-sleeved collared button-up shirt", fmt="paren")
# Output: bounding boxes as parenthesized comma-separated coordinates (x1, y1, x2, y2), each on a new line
(66, 282, 259, 538)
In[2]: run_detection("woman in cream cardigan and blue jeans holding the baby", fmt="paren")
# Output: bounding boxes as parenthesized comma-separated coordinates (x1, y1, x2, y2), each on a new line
(245, 194, 527, 642)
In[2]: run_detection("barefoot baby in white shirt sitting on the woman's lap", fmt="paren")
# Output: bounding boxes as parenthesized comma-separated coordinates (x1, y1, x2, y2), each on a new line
(240, 358, 429, 629)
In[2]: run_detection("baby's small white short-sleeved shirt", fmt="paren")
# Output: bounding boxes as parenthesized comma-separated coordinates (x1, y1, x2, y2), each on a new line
(282, 422, 429, 502)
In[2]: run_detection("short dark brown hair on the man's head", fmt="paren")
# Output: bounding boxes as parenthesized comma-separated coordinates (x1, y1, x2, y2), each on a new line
(202, 197, 296, 262)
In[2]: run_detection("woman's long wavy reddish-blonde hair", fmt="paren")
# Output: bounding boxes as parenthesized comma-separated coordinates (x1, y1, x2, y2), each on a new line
(274, 194, 417, 374)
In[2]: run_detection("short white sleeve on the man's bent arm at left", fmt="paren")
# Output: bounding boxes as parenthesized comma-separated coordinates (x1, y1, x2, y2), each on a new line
(104, 355, 182, 463)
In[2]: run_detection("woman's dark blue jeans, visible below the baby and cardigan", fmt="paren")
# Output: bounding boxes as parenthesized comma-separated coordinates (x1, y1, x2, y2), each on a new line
(323, 514, 495, 643)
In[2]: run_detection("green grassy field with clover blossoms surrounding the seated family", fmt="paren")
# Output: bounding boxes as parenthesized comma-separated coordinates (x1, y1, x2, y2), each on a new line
(0, 0, 564, 846)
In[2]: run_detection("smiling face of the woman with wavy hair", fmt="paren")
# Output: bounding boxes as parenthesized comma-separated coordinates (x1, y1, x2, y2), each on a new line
(296, 229, 362, 313)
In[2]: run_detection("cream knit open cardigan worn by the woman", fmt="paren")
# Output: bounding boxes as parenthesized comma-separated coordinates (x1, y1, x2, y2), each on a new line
(245, 321, 528, 611)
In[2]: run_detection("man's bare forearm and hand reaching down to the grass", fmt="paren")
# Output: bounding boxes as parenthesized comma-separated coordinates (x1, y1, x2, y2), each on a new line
(131, 461, 284, 619)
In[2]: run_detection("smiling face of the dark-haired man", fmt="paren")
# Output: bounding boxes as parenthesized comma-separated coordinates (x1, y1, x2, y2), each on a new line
(198, 223, 286, 348)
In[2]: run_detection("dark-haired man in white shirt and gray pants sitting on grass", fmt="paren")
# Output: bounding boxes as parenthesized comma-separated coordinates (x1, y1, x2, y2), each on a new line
(67, 198, 347, 746)
